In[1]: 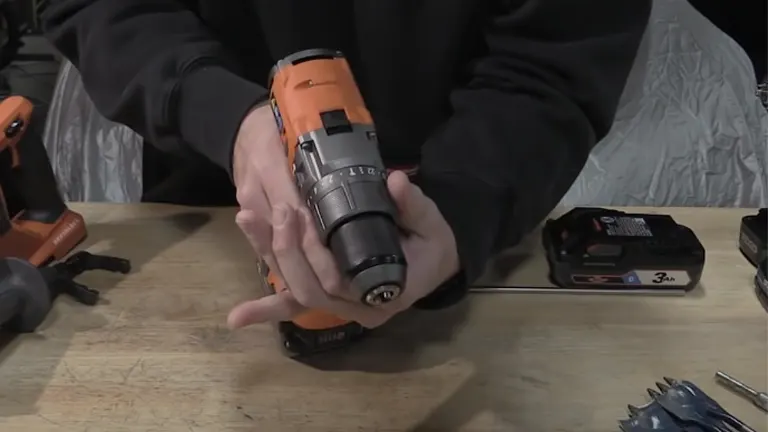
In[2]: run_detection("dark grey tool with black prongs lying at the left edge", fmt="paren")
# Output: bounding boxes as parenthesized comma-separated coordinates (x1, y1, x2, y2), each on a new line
(0, 252, 131, 333)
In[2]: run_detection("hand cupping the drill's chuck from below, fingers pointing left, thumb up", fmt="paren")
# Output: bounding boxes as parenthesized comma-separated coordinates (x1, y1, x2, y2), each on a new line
(228, 171, 459, 328)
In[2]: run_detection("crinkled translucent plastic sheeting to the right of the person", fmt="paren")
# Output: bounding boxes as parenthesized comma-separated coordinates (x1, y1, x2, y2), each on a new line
(562, 0, 768, 207)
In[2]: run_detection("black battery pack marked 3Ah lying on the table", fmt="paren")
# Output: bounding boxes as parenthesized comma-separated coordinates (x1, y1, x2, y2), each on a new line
(542, 208, 705, 292)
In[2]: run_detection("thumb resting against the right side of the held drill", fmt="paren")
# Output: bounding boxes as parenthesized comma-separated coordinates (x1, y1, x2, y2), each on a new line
(387, 171, 441, 237)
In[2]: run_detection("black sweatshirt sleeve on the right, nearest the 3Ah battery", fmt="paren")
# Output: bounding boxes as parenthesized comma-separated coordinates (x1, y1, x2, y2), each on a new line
(416, 0, 651, 308)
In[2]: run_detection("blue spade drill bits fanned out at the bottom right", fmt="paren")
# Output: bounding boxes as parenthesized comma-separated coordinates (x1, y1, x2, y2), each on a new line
(619, 378, 755, 432)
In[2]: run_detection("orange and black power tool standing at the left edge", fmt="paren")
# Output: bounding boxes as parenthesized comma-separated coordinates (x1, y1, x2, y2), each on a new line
(0, 96, 86, 267)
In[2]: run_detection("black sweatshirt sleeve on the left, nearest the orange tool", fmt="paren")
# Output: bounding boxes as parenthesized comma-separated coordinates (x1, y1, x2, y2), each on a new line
(43, 0, 267, 174)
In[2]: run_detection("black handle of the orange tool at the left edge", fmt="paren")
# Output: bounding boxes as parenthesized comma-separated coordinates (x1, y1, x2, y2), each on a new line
(13, 127, 67, 223)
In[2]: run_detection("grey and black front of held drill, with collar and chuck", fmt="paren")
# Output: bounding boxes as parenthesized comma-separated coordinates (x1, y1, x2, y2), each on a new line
(294, 124, 406, 304)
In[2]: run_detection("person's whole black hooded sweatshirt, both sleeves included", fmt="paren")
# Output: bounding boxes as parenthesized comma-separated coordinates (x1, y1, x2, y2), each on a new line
(44, 0, 651, 307)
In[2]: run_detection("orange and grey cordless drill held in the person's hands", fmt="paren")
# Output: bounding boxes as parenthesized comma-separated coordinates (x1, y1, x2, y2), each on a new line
(265, 49, 407, 356)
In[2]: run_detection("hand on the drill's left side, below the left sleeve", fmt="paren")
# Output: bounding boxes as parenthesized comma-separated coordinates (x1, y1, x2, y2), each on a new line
(232, 105, 301, 278)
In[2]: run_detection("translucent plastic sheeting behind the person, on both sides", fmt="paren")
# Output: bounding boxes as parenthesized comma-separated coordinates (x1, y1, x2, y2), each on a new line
(45, 0, 768, 207)
